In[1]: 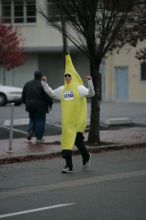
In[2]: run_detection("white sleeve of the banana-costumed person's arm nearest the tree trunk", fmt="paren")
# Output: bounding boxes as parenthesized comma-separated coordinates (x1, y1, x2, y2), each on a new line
(78, 79, 95, 98)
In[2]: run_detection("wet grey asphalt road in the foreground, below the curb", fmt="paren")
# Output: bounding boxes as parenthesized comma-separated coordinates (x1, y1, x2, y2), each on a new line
(0, 149, 146, 220)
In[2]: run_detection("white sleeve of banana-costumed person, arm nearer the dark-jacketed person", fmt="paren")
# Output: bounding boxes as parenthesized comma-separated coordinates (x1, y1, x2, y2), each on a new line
(41, 81, 63, 100)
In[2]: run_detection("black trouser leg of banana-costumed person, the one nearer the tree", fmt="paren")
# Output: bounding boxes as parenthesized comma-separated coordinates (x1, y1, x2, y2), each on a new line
(75, 132, 90, 162)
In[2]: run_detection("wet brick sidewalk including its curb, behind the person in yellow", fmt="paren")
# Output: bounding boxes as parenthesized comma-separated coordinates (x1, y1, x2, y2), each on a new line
(0, 127, 146, 164)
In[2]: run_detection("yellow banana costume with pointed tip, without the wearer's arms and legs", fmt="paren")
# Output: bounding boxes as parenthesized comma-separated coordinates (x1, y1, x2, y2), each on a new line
(61, 55, 87, 150)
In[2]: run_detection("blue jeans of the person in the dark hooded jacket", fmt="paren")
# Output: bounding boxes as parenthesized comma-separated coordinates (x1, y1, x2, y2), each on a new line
(28, 113, 46, 140)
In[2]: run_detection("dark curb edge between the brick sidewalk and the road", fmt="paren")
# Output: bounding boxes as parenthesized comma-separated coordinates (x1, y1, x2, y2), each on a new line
(0, 142, 146, 165)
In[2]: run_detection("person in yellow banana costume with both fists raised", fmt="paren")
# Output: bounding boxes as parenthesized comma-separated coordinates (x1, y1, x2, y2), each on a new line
(42, 54, 95, 173)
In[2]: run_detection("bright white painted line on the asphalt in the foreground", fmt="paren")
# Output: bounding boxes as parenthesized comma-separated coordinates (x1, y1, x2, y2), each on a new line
(0, 203, 76, 219)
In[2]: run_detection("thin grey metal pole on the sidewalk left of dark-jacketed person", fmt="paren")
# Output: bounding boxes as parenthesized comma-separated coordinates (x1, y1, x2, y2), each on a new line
(9, 103, 14, 153)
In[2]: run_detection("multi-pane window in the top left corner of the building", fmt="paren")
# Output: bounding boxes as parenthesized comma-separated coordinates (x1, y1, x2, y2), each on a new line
(1, 0, 36, 24)
